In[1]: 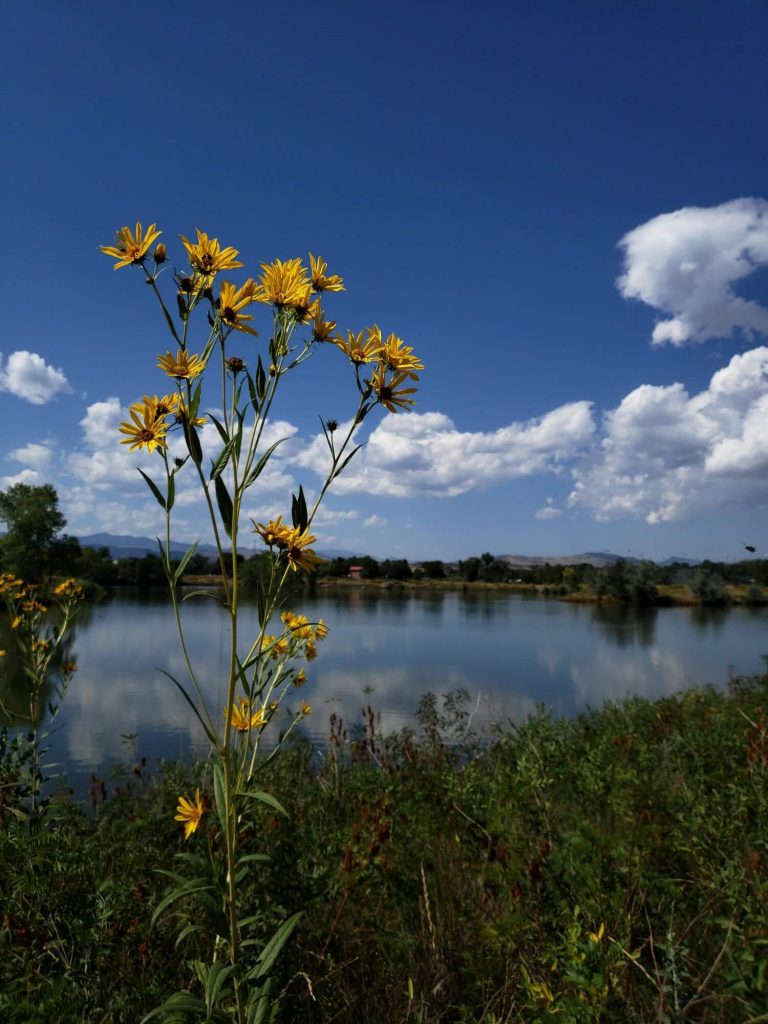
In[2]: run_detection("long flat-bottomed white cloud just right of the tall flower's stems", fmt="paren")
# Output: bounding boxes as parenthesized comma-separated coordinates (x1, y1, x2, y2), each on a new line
(294, 401, 595, 498)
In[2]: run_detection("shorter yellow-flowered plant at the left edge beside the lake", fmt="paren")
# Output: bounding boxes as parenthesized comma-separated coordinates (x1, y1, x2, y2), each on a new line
(0, 572, 83, 827)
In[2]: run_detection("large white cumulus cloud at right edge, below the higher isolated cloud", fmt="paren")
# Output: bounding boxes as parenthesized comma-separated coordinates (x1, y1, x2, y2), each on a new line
(568, 347, 768, 523)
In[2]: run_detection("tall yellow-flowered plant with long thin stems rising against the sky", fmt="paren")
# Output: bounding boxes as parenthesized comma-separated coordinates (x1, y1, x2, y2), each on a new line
(101, 223, 423, 1024)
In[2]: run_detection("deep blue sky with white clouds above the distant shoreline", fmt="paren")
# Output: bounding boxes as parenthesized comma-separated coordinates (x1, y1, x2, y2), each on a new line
(0, 0, 768, 559)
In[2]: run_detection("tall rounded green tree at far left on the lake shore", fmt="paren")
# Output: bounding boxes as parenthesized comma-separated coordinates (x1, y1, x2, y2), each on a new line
(0, 483, 67, 582)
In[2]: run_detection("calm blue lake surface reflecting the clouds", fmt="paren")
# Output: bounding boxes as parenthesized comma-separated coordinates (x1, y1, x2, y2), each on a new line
(0, 588, 768, 788)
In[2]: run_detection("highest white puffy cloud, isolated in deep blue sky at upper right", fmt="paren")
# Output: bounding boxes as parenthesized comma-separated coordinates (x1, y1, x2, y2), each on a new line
(616, 199, 768, 345)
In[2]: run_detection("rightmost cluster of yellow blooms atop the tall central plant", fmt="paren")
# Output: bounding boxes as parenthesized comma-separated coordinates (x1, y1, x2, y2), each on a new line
(331, 324, 424, 413)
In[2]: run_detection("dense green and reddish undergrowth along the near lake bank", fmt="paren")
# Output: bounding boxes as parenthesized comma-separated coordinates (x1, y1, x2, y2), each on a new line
(0, 675, 768, 1024)
